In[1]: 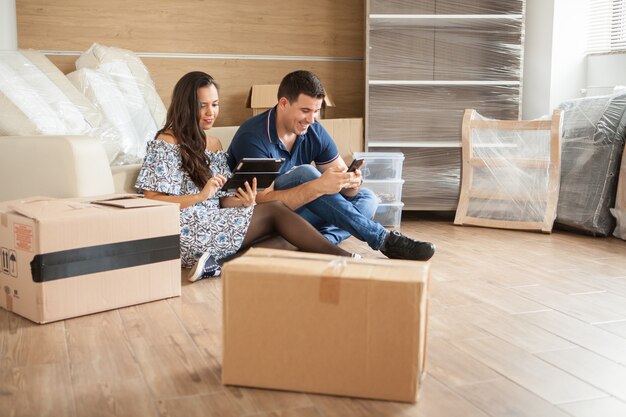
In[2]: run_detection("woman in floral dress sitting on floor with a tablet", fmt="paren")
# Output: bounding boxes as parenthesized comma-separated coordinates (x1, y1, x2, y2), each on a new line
(135, 71, 352, 281)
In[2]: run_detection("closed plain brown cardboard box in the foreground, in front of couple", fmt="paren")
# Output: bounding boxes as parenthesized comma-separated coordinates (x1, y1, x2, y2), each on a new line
(222, 249, 430, 402)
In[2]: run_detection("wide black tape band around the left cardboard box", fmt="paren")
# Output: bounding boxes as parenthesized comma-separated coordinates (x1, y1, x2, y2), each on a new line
(30, 235, 180, 282)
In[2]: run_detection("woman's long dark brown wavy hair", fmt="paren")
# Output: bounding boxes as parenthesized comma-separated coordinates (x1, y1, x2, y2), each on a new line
(155, 71, 218, 189)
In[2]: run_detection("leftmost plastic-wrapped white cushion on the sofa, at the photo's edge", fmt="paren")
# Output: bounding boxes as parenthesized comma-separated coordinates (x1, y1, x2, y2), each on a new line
(0, 50, 120, 161)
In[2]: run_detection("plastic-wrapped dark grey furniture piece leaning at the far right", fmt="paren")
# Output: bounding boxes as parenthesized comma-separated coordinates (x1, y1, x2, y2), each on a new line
(556, 92, 626, 236)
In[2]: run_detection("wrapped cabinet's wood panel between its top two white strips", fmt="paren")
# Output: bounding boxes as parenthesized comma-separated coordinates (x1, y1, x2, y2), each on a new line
(368, 17, 522, 81)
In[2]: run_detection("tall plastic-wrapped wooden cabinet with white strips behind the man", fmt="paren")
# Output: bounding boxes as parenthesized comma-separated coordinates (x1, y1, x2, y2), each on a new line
(365, 0, 525, 210)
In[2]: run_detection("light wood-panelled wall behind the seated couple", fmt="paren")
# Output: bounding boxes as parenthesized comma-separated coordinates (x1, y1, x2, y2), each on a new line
(14, 0, 365, 126)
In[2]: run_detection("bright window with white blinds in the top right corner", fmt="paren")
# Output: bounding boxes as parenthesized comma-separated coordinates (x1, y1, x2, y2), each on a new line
(587, 0, 626, 53)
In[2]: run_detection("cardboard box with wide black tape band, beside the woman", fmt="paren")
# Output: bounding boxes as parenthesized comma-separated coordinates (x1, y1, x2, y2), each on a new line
(0, 196, 180, 323)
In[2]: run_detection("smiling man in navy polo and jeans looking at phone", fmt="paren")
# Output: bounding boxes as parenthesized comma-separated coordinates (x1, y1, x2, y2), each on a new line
(228, 71, 435, 260)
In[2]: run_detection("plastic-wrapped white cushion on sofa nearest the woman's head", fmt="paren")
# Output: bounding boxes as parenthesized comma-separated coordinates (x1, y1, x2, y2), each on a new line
(76, 43, 167, 163)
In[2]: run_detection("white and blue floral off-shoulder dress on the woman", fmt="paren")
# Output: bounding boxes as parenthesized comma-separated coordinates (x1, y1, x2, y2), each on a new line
(135, 139, 253, 268)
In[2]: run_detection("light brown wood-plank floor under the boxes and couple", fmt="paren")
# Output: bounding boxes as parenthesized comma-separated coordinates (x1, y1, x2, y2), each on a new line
(0, 214, 626, 417)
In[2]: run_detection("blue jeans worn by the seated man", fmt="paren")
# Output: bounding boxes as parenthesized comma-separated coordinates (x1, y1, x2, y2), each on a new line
(274, 165, 389, 250)
